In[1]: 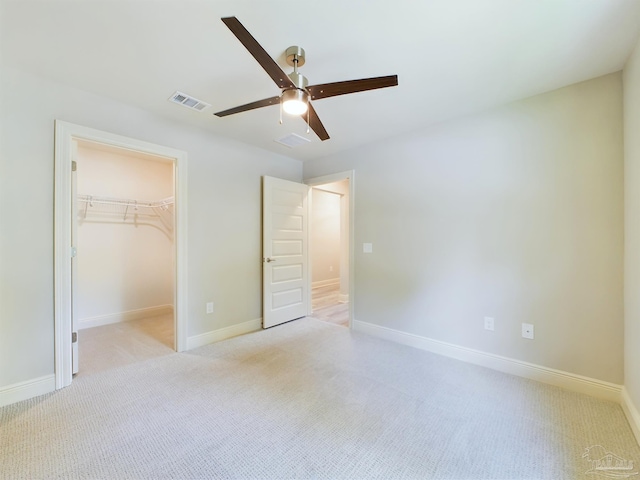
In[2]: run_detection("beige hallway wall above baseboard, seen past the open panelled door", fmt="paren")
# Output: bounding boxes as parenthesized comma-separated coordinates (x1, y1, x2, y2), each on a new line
(311, 188, 340, 284)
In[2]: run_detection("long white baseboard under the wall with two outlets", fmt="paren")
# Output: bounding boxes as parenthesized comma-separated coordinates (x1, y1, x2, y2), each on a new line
(352, 319, 623, 403)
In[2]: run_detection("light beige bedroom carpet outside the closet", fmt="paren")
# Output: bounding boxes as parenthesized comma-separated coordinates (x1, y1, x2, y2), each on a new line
(0, 318, 640, 479)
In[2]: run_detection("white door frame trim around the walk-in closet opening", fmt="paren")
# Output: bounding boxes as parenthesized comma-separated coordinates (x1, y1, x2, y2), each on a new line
(54, 120, 188, 390)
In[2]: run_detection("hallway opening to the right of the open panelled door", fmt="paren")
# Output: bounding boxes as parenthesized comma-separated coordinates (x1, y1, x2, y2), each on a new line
(307, 172, 353, 327)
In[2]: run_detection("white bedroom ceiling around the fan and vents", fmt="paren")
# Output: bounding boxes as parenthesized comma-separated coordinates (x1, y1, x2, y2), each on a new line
(0, 0, 640, 160)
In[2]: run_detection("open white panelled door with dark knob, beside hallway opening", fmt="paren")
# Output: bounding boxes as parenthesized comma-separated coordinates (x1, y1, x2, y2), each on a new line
(262, 177, 309, 328)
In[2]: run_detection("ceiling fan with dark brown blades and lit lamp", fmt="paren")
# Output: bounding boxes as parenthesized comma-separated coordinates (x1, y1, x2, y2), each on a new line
(215, 17, 398, 140)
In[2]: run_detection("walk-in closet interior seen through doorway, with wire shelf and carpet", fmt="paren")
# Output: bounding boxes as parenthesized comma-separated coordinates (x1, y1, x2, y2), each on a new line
(72, 140, 175, 376)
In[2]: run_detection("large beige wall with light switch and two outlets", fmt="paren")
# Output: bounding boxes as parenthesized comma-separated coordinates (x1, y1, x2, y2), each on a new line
(304, 73, 623, 383)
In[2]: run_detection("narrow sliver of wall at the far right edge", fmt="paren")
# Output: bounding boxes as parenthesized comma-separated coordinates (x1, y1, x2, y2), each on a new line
(623, 36, 640, 409)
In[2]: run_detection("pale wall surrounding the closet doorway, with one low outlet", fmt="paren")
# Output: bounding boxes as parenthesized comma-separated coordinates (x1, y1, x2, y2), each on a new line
(0, 67, 302, 388)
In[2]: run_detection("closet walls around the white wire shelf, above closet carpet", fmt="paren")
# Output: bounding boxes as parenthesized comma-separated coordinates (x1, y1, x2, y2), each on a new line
(76, 142, 174, 328)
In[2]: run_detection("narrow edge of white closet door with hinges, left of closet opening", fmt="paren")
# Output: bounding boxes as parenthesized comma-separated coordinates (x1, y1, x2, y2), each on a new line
(71, 140, 80, 374)
